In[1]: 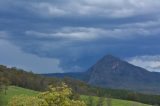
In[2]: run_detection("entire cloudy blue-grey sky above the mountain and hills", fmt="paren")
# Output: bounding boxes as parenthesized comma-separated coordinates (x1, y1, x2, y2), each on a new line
(0, 0, 160, 73)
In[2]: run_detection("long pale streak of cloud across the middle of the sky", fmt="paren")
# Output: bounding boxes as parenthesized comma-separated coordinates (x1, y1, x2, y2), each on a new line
(25, 25, 160, 41)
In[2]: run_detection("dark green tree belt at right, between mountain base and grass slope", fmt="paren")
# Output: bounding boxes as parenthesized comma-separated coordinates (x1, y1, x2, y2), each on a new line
(90, 87, 160, 105)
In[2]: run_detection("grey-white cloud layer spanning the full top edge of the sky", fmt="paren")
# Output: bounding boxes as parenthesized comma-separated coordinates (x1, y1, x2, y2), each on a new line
(0, 0, 160, 18)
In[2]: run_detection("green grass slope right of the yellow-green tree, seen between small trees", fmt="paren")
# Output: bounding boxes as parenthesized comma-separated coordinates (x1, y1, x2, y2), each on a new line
(81, 95, 151, 106)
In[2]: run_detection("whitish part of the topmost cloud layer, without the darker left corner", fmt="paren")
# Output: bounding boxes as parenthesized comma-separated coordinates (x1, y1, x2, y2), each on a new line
(28, 0, 160, 18)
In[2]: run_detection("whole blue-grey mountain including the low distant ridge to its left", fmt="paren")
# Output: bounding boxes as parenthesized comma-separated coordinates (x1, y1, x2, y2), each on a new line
(43, 55, 160, 93)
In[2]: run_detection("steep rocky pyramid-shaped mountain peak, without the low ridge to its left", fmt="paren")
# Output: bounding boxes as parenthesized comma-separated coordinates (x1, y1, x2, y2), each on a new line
(87, 55, 159, 89)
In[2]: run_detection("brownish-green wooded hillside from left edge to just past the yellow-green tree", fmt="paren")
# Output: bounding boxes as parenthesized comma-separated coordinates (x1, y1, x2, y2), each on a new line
(0, 65, 88, 99)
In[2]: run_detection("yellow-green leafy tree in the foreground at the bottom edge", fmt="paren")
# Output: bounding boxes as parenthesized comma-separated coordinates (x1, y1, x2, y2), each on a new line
(9, 84, 86, 106)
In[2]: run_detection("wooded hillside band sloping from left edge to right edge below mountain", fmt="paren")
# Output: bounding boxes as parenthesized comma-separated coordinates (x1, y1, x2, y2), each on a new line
(0, 65, 160, 105)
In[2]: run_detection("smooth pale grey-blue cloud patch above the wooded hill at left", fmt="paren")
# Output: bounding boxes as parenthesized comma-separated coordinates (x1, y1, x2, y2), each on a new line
(0, 40, 63, 73)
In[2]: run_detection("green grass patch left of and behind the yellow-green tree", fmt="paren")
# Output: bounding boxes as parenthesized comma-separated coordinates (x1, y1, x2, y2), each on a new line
(0, 86, 38, 106)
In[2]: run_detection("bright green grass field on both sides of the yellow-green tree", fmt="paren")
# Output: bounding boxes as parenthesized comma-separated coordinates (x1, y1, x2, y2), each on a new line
(0, 86, 150, 106)
